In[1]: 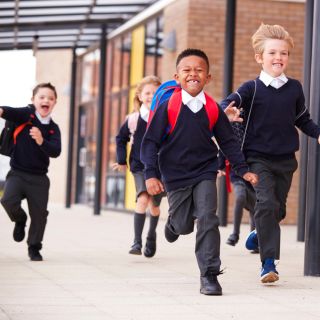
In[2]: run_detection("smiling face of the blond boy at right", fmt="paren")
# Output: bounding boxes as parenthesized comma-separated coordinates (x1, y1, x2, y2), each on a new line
(255, 39, 289, 78)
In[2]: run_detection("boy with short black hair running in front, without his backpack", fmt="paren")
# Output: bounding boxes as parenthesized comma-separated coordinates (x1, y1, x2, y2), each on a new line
(141, 49, 257, 295)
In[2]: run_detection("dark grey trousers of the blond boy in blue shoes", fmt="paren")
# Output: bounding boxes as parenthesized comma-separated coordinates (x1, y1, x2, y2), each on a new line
(247, 157, 298, 262)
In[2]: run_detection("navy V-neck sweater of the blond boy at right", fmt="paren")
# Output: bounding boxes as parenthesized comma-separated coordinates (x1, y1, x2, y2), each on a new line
(221, 78, 320, 160)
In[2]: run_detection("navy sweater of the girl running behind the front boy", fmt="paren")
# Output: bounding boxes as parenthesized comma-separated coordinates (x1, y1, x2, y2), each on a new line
(116, 115, 147, 173)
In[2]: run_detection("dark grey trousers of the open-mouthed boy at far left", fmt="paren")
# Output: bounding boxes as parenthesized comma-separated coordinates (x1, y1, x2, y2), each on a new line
(1, 170, 50, 250)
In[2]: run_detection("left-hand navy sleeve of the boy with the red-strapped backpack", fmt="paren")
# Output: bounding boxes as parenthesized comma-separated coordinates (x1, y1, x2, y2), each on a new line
(140, 103, 168, 179)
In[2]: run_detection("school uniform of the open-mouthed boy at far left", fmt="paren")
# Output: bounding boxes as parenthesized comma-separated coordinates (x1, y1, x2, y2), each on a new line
(1, 105, 61, 250)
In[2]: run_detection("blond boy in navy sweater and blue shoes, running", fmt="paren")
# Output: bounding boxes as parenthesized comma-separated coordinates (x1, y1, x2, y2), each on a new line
(221, 24, 320, 283)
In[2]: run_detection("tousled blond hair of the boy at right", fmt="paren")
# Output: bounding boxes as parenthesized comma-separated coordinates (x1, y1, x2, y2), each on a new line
(251, 23, 294, 54)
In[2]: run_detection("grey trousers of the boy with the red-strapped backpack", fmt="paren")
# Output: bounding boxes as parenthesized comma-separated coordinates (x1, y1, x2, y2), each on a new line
(167, 179, 221, 276)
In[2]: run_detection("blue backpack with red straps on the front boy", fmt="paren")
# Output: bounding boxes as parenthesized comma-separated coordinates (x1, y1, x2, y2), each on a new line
(147, 80, 219, 138)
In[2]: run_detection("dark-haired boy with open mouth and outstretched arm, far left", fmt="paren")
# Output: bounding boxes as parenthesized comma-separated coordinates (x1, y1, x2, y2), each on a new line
(0, 83, 61, 261)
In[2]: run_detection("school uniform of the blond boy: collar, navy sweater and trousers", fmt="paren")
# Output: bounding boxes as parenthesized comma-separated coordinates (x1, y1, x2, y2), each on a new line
(221, 71, 320, 261)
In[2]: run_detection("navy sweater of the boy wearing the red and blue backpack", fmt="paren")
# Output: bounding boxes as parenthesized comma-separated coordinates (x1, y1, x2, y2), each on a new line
(141, 102, 248, 191)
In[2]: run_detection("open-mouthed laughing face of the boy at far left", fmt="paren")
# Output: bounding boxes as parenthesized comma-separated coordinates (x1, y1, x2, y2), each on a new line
(31, 88, 57, 118)
